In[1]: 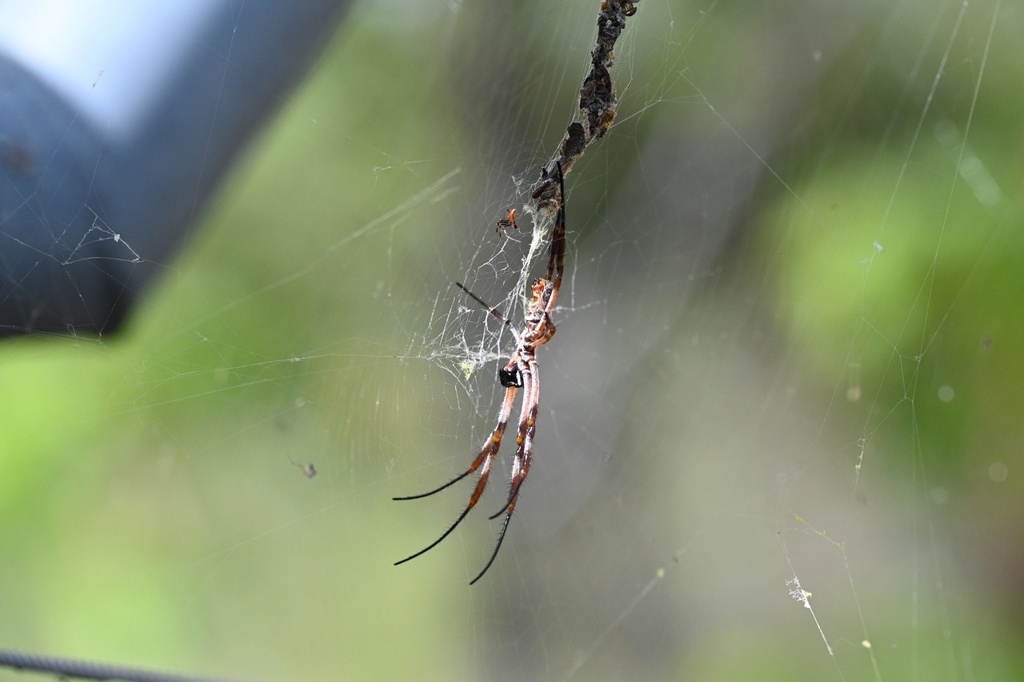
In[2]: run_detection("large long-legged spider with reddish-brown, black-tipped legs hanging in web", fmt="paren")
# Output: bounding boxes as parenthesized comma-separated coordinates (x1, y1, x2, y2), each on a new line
(394, 161, 565, 585)
